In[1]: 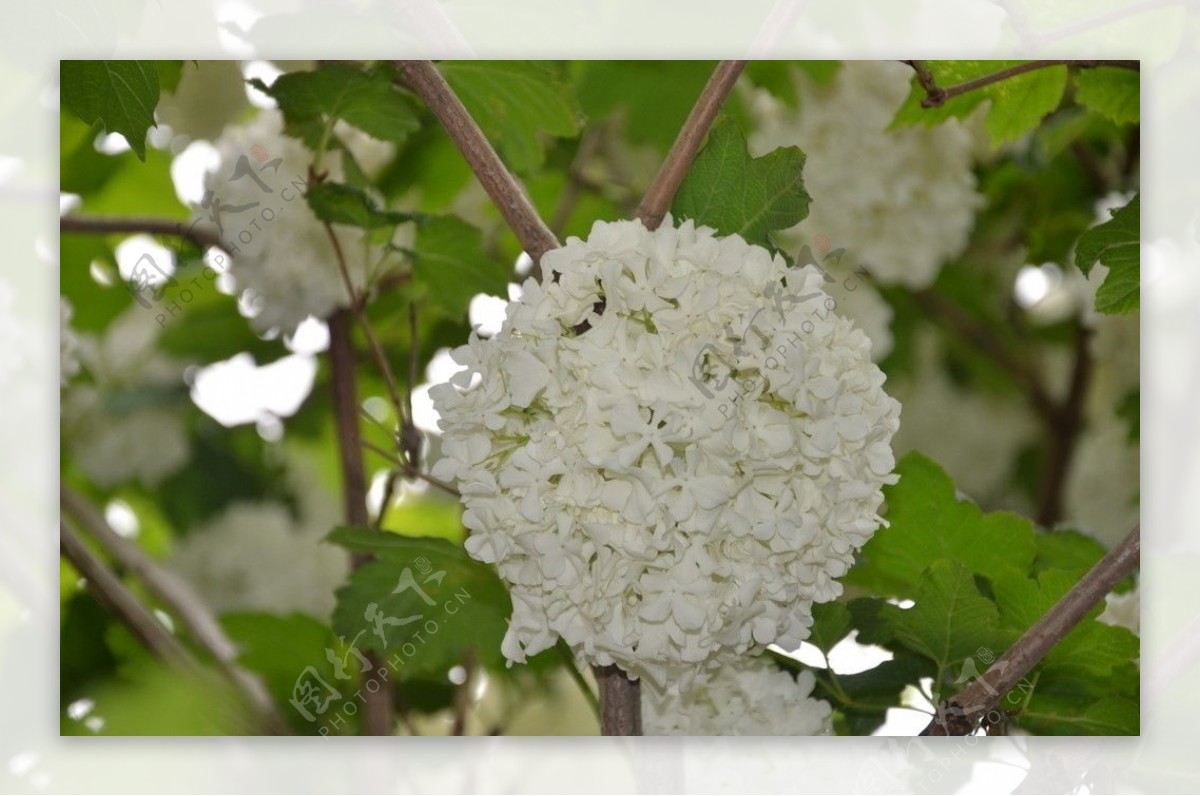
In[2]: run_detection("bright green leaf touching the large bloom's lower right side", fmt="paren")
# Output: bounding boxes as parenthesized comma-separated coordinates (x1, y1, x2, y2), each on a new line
(845, 451, 1034, 597)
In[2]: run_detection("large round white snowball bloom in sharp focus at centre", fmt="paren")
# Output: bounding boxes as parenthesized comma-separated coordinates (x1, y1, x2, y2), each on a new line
(430, 219, 900, 683)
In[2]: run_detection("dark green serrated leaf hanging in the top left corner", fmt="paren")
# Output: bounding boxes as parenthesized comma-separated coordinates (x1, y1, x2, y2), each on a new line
(59, 61, 158, 160)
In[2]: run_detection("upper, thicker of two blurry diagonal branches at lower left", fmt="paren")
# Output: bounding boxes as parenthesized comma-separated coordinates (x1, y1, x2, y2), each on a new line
(59, 484, 286, 730)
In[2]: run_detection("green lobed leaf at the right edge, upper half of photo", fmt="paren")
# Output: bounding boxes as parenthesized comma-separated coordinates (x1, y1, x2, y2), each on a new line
(1075, 193, 1141, 315)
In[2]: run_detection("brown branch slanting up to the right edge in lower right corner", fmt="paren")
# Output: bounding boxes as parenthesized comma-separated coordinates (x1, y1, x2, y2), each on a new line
(922, 526, 1141, 735)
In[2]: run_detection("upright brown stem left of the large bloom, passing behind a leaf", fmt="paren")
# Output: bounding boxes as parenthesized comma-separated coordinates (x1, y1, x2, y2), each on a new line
(328, 310, 391, 735)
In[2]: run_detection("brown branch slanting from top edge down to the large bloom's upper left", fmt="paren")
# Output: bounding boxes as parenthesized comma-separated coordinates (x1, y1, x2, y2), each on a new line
(396, 61, 559, 263)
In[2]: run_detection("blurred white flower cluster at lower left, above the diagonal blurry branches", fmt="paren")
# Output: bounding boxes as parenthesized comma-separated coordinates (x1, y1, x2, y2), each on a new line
(167, 460, 349, 620)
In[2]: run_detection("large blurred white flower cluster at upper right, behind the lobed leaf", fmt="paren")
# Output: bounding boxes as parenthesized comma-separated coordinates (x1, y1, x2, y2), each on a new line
(750, 61, 983, 359)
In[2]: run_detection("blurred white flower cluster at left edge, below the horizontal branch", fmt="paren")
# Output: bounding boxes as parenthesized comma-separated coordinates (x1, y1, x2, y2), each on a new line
(61, 304, 191, 487)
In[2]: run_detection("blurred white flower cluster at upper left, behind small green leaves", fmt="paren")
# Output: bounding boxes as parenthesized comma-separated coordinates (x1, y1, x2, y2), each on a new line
(196, 110, 395, 334)
